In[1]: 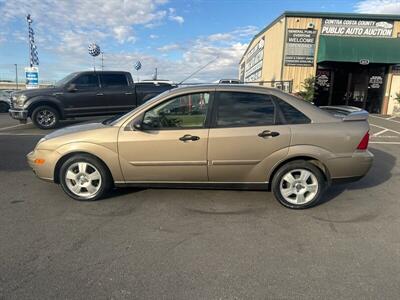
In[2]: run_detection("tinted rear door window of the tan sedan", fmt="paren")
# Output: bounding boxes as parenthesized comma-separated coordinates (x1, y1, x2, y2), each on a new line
(216, 92, 275, 127)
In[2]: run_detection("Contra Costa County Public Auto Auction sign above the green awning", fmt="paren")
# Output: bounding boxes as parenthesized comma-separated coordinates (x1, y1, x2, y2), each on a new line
(321, 19, 393, 38)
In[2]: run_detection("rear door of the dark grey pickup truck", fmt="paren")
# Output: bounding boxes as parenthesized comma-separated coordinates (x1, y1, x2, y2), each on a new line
(100, 73, 136, 113)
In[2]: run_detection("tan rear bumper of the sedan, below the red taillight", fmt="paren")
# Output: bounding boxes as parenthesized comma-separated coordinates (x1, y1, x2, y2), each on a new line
(326, 151, 374, 183)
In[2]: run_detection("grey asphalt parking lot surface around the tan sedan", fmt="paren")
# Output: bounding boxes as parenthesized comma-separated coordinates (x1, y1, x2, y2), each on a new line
(0, 114, 400, 299)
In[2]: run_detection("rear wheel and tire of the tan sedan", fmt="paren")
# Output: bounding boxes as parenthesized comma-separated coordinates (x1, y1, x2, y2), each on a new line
(271, 160, 327, 209)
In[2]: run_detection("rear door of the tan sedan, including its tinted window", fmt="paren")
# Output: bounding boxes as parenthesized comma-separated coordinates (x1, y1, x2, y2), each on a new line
(208, 91, 290, 183)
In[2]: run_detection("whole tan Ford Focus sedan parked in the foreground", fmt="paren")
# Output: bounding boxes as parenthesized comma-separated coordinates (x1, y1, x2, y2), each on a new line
(27, 85, 373, 209)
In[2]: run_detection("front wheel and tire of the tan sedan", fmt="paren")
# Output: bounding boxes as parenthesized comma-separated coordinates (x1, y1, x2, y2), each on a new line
(59, 154, 112, 201)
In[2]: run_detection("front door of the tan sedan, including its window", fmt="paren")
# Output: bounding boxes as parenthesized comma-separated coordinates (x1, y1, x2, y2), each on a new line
(118, 92, 211, 182)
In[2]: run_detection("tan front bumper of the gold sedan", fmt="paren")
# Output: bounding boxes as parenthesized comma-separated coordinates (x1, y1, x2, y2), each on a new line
(26, 149, 61, 181)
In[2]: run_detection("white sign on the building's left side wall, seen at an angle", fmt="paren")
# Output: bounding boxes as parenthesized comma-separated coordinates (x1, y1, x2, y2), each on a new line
(244, 37, 265, 82)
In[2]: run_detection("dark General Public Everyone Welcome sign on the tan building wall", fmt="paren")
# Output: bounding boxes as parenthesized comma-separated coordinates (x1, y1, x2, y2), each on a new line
(285, 29, 317, 67)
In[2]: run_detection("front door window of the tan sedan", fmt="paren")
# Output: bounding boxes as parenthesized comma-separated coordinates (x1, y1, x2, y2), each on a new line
(142, 93, 210, 130)
